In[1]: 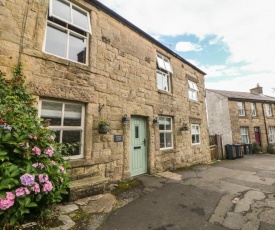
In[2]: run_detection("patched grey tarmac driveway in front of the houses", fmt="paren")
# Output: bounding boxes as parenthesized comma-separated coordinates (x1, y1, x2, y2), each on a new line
(100, 154, 275, 230)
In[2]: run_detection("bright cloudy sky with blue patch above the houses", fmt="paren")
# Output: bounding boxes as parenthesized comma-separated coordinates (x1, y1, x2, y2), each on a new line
(100, 0, 275, 97)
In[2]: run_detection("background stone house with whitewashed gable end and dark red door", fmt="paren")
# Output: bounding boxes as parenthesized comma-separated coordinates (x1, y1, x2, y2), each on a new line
(206, 84, 275, 157)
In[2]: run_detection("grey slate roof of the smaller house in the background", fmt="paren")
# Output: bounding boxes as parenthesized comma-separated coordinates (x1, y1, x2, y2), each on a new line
(206, 89, 275, 103)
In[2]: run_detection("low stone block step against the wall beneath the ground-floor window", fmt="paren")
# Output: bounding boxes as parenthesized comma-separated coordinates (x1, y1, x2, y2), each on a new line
(69, 176, 110, 201)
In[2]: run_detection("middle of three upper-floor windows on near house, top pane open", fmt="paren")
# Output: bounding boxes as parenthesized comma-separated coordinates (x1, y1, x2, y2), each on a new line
(157, 54, 173, 92)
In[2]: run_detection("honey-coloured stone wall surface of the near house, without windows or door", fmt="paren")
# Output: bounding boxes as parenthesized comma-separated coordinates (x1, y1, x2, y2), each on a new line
(0, 0, 210, 183)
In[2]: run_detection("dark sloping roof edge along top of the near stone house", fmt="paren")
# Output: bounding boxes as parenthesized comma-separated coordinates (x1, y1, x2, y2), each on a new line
(84, 0, 206, 75)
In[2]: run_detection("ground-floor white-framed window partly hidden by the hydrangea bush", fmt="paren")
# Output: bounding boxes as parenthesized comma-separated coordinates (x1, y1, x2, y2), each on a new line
(39, 100, 85, 158)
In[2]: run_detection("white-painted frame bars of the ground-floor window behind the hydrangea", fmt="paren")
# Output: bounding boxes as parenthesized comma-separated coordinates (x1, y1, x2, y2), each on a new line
(38, 99, 85, 159)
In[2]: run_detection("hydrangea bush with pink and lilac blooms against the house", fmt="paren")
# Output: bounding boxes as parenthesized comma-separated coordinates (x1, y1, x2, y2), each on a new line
(0, 67, 69, 229)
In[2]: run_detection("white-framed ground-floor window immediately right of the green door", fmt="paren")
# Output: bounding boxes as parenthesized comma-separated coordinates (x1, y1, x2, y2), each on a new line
(159, 117, 173, 150)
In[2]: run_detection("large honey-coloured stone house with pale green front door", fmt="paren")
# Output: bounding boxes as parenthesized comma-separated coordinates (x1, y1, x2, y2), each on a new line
(0, 0, 210, 199)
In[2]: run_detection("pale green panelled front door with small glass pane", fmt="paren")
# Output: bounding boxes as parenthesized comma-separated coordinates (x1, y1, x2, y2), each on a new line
(130, 117, 147, 176)
